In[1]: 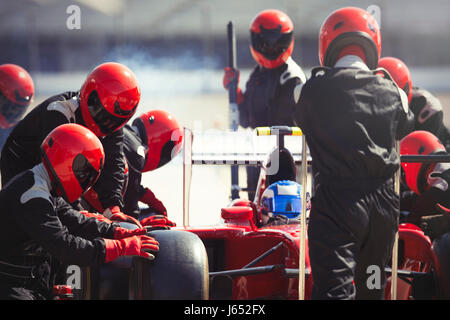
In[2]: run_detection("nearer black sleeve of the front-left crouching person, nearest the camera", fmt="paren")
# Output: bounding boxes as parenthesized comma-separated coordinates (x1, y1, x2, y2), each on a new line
(15, 198, 105, 266)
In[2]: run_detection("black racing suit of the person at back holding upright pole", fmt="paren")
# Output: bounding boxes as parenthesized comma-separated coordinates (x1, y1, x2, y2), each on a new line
(239, 58, 306, 196)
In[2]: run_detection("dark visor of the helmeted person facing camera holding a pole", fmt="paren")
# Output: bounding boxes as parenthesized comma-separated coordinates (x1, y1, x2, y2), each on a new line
(251, 26, 292, 60)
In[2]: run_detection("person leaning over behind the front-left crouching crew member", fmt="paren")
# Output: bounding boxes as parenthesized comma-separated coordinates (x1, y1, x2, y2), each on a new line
(1, 62, 141, 220)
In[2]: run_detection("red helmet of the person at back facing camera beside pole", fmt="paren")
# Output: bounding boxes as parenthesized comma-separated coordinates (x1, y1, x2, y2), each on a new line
(250, 10, 294, 69)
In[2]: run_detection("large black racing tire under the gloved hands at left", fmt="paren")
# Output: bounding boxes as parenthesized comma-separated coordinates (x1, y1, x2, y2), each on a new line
(129, 230, 209, 300)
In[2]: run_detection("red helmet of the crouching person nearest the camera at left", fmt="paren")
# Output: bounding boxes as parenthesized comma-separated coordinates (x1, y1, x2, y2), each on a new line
(41, 123, 105, 203)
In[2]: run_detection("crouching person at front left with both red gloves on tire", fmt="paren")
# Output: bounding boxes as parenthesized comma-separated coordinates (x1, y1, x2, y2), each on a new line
(0, 124, 159, 300)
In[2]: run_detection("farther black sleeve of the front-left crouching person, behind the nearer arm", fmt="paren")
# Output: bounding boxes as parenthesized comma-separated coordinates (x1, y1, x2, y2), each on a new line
(55, 198, 116, 240)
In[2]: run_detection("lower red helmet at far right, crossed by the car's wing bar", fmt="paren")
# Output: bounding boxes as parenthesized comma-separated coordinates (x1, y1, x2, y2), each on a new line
(400, 130, 446, 194)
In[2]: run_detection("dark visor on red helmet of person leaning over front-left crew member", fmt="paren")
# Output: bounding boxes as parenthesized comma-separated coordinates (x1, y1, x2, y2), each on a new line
(87, 91, 128, 135)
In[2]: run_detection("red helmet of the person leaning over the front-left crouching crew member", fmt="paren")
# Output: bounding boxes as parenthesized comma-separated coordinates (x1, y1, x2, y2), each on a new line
(80, 62, 141, 137)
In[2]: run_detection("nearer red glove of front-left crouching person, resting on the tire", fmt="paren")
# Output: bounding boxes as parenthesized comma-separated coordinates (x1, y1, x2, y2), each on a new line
(103, 236, 159, 262)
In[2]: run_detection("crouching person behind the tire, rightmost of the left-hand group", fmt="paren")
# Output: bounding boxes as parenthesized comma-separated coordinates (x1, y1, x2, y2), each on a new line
(82, 110, 183, 226)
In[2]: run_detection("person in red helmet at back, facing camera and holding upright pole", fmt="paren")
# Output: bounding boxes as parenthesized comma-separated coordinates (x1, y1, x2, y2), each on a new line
(223, 10, 306, 200)
